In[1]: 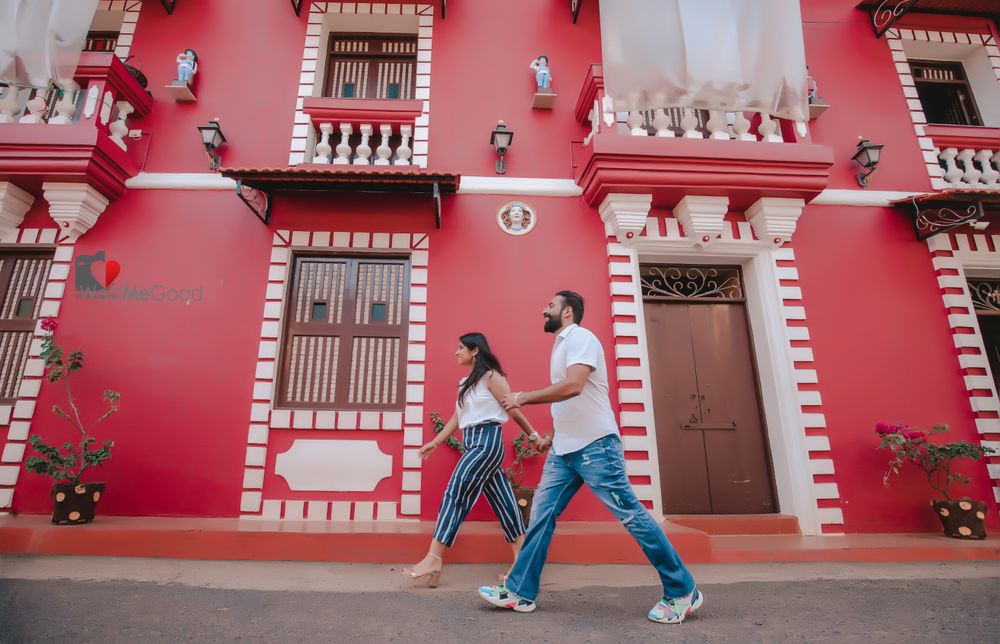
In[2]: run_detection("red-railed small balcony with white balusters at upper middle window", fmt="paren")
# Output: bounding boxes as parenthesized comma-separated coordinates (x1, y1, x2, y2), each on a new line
(302, 98, 423, 166)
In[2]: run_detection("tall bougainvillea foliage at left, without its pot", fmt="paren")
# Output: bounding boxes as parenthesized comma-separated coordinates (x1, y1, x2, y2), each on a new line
(25, 318, 120, 484)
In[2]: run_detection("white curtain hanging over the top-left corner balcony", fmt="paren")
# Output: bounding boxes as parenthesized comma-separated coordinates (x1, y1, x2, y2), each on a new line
(0, 0, 98, 87)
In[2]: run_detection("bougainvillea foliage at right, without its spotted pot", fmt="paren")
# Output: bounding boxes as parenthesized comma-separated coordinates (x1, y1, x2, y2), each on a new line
(875, 423, 993, 501)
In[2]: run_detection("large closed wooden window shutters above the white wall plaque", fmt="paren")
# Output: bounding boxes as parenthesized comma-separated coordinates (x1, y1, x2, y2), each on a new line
(278, 256, 410, 410)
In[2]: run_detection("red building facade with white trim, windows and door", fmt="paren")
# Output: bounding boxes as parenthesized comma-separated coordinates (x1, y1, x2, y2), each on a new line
(0, 0, 1000, 534)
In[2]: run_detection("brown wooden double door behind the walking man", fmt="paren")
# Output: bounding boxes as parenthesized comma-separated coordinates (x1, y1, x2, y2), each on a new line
(644, 300, 776, 514)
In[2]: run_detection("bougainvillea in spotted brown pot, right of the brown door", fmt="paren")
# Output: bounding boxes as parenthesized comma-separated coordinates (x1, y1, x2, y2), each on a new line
(875, 423, 993, 539)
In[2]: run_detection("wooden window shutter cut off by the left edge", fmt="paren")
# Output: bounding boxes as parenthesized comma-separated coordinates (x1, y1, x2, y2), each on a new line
(0, 251, 53, 402)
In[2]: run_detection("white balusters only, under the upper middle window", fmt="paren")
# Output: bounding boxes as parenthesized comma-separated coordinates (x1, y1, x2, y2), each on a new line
(312, 122, 413, 166)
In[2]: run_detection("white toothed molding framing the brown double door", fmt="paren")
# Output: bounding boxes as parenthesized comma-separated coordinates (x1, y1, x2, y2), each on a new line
(605, 200, 844, 534)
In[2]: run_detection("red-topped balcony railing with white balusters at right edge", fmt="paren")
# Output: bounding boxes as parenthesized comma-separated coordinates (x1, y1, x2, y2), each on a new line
(925, 125, 1000, 188)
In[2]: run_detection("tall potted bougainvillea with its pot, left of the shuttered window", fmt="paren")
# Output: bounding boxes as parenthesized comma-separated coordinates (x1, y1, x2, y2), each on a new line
(25, 318, 120, 523)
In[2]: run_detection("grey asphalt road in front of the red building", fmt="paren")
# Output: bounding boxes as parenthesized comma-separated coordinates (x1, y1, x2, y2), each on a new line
(0, 565, 1000, 644)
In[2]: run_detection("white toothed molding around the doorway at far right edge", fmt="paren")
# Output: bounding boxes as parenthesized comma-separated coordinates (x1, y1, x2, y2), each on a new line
(927, 234, 1000, 503)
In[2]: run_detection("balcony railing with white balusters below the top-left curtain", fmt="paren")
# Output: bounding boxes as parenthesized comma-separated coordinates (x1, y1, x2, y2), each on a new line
(0, 52, 152, 150)
